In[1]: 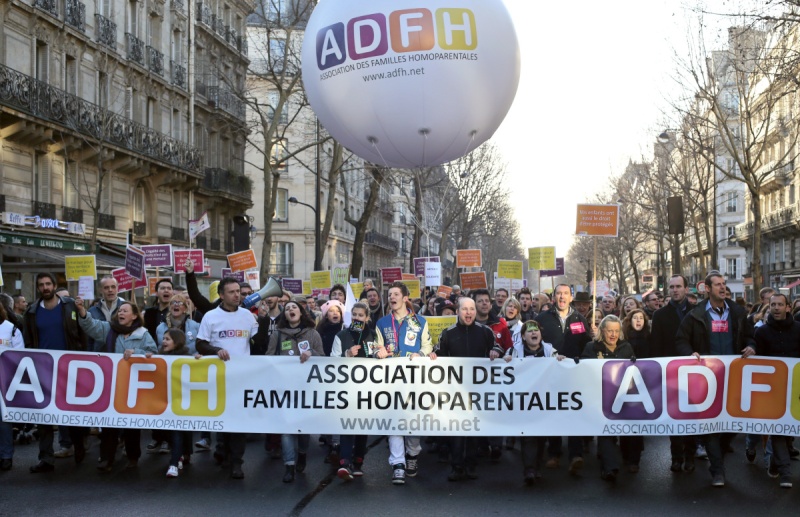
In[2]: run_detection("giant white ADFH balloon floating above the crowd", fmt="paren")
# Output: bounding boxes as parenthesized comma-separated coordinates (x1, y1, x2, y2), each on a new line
(303, 0, 520, 168)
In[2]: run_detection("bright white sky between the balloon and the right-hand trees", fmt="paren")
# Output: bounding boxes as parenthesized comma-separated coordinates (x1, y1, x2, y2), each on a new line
(493, 0, 740, 256)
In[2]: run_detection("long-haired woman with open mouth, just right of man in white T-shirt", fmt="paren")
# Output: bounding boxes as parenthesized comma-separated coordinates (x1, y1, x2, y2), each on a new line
(266, 301, 324, 483)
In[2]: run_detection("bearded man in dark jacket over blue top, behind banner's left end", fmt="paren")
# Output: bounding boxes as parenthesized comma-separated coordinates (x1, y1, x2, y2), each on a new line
(23, 273, 87, 474)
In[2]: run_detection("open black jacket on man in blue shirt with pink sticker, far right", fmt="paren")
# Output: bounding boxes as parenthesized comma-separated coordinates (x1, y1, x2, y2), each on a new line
(675, 300, 748, 355)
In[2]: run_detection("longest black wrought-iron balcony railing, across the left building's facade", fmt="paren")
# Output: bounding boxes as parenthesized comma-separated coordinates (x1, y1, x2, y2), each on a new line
(0, 65, 203, 171)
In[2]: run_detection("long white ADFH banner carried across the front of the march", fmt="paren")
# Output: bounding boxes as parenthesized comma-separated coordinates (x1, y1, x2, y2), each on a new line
(0, 349, 800, 436)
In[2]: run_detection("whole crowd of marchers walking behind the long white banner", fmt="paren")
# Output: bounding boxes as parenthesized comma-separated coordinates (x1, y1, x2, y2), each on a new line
(0, 261, 800, 488)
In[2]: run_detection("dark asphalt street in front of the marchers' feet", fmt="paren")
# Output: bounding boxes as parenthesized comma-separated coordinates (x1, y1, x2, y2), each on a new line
(0, 436, 800, 517)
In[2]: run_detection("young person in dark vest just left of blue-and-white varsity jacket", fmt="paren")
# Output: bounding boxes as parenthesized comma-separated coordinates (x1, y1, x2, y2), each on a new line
(331, 302, 383, 481)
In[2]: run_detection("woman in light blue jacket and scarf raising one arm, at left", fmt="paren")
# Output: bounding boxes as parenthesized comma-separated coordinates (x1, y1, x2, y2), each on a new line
(75, 298, 158, 472)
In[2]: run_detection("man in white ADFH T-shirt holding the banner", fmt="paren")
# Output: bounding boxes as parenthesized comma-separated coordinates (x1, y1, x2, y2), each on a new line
(197, 278, 258, 479)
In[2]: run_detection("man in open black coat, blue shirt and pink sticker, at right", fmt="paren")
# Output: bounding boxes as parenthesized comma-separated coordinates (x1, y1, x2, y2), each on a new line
(675, 272, 748, 487)
